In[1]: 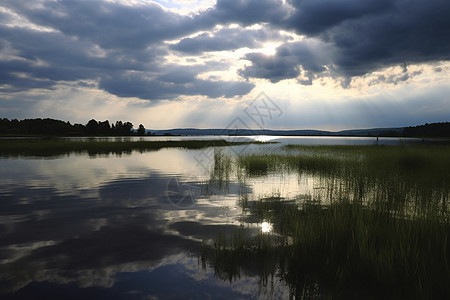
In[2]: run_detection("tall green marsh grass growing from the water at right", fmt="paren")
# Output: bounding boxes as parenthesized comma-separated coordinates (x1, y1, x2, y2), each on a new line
(209, 145, 450, 299)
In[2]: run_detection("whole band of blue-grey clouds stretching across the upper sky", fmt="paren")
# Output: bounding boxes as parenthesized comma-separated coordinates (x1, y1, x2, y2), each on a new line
(0, 0, 450, 99)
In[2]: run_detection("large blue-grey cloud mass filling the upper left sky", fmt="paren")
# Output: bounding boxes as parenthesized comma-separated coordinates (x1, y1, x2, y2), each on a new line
(0, 0, 253, 100)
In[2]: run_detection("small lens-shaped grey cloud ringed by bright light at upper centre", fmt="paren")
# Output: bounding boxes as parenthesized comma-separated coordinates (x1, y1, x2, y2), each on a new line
(170, 28, 286, 54)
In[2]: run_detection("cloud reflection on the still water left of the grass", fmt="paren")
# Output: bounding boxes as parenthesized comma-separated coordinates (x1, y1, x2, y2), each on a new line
(0, 149, 282, 296)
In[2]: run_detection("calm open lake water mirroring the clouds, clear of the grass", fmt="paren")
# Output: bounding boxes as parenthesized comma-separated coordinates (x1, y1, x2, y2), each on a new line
(0, 137, 428, 299)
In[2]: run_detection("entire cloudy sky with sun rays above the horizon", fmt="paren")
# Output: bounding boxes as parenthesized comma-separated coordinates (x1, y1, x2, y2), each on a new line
(0, 0, 450, 130)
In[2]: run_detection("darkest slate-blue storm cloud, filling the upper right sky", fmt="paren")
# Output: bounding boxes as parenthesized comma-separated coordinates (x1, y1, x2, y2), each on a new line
(241, 0, 450, 84)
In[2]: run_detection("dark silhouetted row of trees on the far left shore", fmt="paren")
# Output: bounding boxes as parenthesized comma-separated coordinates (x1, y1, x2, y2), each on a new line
(0, 118, 150, 136)
